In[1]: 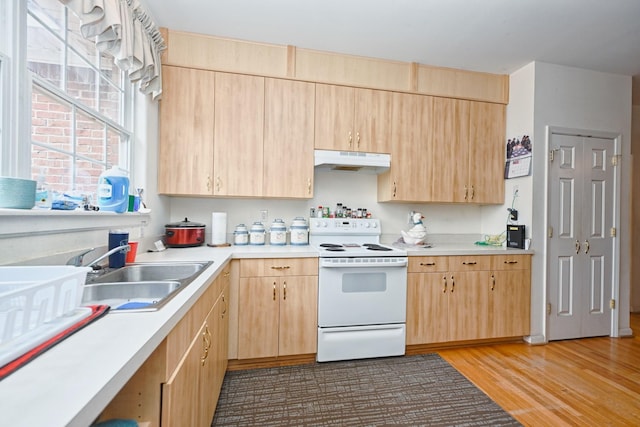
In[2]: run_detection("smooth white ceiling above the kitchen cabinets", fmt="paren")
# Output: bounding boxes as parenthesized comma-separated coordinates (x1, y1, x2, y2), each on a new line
(141, 0, 640, 75)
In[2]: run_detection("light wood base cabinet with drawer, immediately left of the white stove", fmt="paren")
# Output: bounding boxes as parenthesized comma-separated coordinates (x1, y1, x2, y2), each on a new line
(238, 258, 318, 359)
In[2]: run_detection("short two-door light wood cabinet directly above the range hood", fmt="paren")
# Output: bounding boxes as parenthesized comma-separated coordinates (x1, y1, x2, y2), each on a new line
(315, 84, 392, 153)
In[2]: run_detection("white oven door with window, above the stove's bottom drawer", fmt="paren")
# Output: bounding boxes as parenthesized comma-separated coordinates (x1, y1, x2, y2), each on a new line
(318, 257, 407, 328)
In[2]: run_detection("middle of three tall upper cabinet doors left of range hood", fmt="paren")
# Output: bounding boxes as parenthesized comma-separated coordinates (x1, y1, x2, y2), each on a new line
(213, 73, 264, 197)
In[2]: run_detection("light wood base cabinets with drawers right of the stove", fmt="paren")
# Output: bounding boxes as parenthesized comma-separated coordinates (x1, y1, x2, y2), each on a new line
(407, 255, 531, 345)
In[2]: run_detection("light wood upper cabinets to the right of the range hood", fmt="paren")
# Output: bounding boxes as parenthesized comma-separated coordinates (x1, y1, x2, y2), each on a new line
(378, 94, 505, 204)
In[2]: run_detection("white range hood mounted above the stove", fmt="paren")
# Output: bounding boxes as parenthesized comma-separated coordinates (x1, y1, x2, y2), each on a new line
(314, 150, 391, 174)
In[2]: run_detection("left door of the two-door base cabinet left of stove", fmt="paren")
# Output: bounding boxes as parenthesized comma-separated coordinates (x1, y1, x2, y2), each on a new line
(238, 277, 280, 359)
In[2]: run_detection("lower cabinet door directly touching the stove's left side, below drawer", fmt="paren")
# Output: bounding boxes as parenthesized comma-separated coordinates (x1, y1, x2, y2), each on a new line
(278, 276, 318, 356)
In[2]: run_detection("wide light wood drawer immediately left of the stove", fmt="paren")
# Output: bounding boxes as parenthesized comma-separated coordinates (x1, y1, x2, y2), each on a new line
(240, 258, 318, 277)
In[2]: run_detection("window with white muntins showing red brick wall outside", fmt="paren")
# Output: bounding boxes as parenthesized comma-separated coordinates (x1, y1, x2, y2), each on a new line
(26, 0, 133, 195)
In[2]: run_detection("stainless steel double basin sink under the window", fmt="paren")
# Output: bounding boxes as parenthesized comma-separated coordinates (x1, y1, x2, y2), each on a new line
(82, 261, 213, 312)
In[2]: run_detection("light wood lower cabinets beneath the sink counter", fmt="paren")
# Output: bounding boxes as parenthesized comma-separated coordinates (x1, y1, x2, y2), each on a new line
(99, 264, 230, 427)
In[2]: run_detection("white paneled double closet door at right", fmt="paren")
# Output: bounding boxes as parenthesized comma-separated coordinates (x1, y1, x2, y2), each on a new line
(547, 133, 615, 340)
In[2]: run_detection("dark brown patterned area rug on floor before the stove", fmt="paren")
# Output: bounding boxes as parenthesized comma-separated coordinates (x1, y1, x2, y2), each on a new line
(212, 354, 520, 426)
